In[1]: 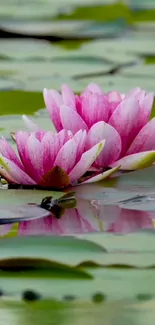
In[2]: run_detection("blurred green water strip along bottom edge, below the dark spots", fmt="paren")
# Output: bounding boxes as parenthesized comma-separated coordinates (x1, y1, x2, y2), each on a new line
(0, 297, 150, 325)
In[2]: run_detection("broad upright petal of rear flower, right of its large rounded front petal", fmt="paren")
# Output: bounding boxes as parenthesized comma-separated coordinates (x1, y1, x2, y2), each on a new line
(108, 98, 143, 156)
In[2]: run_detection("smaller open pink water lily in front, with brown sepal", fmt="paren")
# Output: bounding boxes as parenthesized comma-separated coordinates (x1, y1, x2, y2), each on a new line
(0, 130, 116, 188)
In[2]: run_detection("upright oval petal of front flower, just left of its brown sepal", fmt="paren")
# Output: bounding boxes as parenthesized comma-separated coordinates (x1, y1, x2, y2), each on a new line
(24, 135, 44, 183)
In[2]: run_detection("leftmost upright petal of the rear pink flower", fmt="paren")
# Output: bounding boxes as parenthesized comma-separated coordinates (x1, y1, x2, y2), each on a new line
(43, 88, 63, 131)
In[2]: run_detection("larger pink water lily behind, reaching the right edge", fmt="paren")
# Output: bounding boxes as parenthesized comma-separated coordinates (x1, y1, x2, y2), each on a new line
(39, 84, 155, 170)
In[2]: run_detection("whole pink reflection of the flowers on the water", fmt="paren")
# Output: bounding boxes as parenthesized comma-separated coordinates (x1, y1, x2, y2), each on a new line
(0, 195, 155, 236)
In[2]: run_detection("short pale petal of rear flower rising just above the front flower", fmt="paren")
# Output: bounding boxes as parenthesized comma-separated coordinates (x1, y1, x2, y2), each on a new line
(60, 106, 88, 134)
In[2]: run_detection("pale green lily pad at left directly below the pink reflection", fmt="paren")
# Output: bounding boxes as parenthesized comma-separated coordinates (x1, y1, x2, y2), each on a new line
(0, 236, 105, 266)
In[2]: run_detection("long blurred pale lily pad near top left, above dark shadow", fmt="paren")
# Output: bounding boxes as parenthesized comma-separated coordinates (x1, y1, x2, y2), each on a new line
(1, 19, 123, 39)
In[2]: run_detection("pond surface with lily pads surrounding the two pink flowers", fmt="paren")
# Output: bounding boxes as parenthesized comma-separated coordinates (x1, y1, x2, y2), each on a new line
(0, 0, 155, 325)
